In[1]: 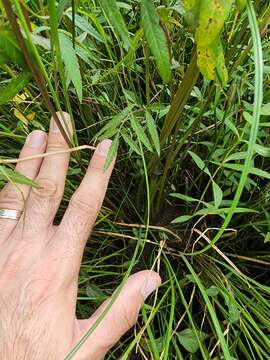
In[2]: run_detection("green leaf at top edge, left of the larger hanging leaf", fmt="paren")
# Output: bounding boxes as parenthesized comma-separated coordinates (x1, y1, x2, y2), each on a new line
(100, 0, 130, 49)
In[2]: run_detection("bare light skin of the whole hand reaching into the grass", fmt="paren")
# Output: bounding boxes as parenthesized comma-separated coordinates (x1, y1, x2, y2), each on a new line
(0, 114, 160, 360)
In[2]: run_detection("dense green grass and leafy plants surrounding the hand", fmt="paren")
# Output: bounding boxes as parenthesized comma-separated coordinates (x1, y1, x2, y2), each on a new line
(0, 0, 270, 360)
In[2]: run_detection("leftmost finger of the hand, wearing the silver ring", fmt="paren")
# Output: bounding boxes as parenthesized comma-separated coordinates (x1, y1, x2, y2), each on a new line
(0, 130, 47, 237)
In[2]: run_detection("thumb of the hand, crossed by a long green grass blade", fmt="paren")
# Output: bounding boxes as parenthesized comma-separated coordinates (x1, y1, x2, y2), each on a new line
(75, 270, 161, 360)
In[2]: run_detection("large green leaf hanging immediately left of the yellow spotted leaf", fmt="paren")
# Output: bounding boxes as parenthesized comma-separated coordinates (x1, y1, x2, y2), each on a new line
(141, 0, 171, 83)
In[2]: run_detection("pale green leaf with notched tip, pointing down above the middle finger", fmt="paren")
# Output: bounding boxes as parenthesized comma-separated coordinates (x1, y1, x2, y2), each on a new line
(59, 32, 82, 102)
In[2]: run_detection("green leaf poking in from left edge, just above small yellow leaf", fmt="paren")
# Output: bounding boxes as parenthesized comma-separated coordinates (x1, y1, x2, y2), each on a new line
(0, 71, 32, 105)
